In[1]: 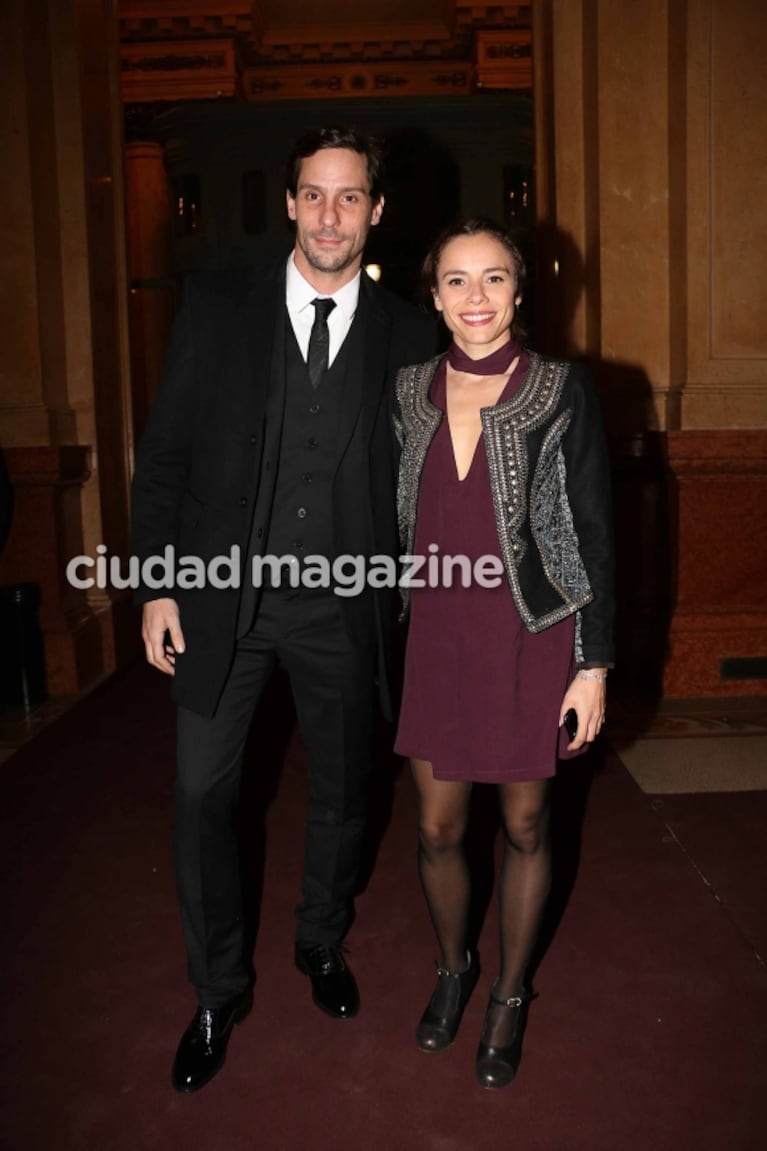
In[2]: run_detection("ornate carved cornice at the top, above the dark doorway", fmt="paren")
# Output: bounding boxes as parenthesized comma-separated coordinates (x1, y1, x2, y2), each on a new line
(117, 0, 532, 102)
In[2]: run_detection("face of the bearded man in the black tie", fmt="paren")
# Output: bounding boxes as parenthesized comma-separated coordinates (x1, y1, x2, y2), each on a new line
(287, 147, 384, 289)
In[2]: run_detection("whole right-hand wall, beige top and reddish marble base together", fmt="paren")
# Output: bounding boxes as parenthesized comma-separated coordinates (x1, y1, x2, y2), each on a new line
(534, 0, 767, 695)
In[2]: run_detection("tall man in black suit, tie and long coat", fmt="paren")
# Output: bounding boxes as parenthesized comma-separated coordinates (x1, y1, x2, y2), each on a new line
(128, 128, 435, 1092)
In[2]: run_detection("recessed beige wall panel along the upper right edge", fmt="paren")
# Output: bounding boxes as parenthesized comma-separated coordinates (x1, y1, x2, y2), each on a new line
(682, 0, 767, 428)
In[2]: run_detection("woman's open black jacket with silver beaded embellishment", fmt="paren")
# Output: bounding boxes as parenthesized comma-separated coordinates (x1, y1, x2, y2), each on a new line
(395, 352, 615, 666)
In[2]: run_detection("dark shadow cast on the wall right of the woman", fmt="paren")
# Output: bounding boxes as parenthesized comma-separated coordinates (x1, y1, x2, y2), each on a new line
(529, 222, 676, 702)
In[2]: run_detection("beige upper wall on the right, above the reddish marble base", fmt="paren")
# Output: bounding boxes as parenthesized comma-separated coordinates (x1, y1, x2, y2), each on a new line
(536, 0, 767, 429)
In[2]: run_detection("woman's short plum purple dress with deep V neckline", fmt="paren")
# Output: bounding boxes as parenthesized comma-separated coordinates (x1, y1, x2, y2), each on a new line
(395, 336, 577, 783)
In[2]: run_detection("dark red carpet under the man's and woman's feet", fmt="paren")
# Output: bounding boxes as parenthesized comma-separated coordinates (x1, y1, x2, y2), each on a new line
(0, 668, 767, 1151)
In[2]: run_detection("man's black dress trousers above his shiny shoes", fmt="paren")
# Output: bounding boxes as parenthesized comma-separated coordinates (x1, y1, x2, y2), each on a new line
(173, 589, 375, 1007)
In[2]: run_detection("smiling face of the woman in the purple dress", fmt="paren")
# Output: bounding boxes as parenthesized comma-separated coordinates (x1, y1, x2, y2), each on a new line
(433, 231, 521, 359)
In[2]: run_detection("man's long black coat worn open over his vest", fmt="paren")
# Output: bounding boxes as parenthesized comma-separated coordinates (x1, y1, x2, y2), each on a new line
(132, 261, 435, 715)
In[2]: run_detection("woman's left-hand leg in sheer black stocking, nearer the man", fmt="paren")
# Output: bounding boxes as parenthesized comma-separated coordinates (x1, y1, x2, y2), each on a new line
(411, 760, 471, 971)
